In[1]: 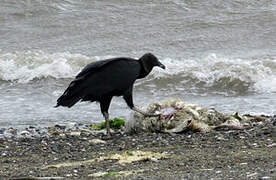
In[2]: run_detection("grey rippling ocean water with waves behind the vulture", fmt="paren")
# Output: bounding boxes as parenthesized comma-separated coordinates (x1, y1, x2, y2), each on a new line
(0, 0, 276, 128)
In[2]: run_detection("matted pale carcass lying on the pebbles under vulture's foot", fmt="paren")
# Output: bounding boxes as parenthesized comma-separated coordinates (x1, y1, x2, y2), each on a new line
(132, 100, 266, 133)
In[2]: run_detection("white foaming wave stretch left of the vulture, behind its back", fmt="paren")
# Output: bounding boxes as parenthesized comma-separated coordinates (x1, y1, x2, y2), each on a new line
(0, 51, 112, 83)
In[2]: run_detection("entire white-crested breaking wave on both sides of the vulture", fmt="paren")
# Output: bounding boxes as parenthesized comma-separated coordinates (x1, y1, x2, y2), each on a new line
(0, 51, 276, 93)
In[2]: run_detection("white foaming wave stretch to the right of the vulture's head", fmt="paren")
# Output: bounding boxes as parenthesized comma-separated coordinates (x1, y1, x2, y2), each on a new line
(155, 54, 276, 92)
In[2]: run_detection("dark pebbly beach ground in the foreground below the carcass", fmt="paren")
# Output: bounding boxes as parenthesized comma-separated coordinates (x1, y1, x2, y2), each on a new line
(0, 116, 276, 179)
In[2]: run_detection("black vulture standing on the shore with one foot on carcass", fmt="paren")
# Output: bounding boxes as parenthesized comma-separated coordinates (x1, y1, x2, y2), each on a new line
(55, 53, 165, 136)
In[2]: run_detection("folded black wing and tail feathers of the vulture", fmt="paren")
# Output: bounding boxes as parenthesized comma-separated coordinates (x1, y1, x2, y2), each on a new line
(57, 58, 141, 107)
